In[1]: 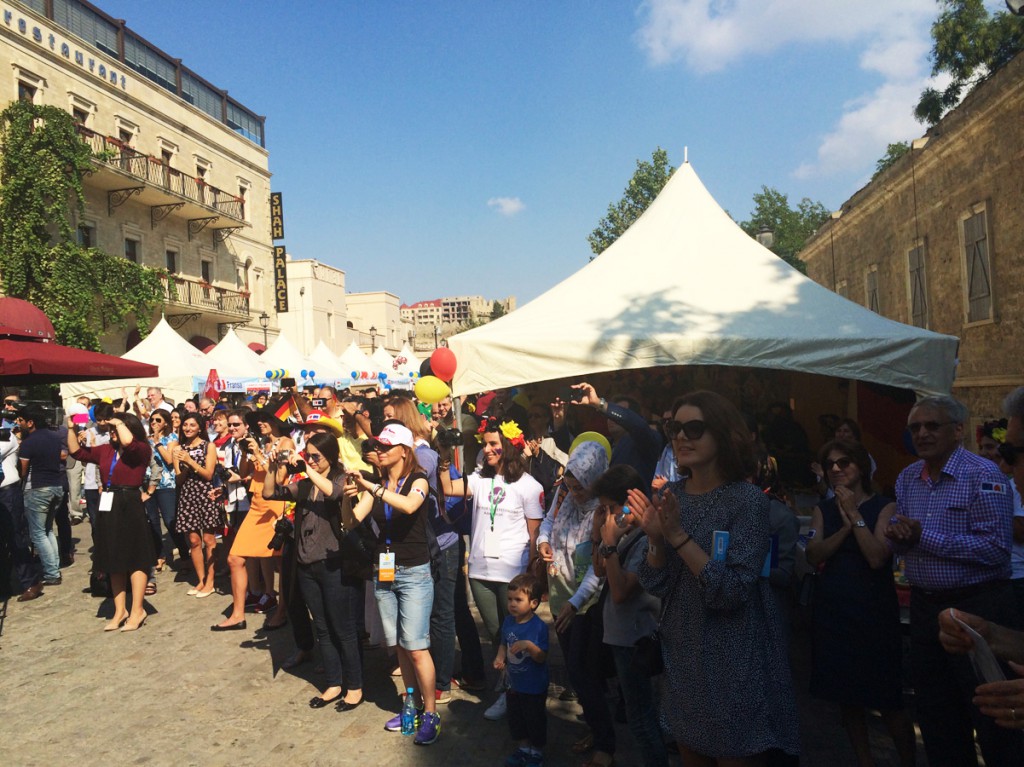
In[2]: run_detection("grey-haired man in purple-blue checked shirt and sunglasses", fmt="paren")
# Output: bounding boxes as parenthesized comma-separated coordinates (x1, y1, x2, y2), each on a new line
(886, 396, 1024, 767)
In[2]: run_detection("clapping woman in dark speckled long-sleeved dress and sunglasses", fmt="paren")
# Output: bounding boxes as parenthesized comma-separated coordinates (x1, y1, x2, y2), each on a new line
(627, 391, 800, 765)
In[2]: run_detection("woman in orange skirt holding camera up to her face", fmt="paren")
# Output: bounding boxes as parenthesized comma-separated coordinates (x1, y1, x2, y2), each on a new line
(210, 409, 295, 631)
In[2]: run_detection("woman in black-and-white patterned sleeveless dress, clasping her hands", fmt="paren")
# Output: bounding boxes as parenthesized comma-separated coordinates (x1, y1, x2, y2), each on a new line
(171, 413, 224, 599)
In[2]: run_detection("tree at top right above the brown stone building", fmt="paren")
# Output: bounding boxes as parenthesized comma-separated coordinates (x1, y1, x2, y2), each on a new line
(913, 0, 1024, 126)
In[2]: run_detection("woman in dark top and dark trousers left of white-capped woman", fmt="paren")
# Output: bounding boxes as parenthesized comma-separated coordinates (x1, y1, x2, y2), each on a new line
(261, 433, 362, 712)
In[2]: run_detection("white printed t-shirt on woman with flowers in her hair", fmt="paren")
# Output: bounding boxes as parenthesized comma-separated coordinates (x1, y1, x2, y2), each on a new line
(466, 473, 544, 583)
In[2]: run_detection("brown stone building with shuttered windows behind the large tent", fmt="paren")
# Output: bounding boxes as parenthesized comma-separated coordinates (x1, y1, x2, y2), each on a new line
(800, 56, 1024, 438)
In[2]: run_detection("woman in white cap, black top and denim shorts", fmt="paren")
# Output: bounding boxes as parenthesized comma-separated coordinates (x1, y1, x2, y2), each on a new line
(346, 421, 440, 745)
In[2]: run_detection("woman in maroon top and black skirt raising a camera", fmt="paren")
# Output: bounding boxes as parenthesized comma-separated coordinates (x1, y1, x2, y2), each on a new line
(68, 413, 157, 631)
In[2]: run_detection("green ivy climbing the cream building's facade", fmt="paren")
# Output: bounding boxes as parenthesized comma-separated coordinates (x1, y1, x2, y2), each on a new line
(0, 101, 163, 350)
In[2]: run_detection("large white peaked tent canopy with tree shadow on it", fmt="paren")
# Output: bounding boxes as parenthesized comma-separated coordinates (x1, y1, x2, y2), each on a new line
(449, 164, 958, 394)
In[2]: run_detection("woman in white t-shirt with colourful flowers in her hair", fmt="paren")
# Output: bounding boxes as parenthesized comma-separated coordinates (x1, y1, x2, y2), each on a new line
(440, 418, 544, 718)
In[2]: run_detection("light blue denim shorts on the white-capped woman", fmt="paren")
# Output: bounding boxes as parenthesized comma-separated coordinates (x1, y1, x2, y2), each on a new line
(374, 562, 434, 650)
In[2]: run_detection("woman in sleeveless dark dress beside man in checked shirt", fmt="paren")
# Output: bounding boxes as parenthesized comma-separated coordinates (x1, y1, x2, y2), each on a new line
(807, 440, 914, 767)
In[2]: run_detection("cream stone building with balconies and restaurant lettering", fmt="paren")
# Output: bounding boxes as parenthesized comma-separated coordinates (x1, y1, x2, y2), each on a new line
(0, 0, 276, 354)
